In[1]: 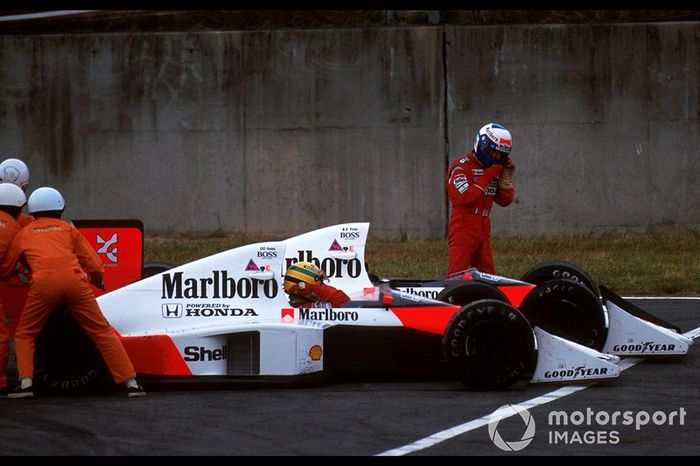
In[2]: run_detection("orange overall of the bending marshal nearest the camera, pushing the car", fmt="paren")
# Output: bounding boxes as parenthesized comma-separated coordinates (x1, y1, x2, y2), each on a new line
(0, 217, 135, 383)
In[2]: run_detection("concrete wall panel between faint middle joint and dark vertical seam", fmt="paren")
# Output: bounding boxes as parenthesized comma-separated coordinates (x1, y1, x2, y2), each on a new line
(245, 29, 446, 237)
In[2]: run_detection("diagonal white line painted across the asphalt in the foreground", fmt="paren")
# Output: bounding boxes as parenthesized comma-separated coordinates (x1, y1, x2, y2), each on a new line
(375, 327, 700, 456)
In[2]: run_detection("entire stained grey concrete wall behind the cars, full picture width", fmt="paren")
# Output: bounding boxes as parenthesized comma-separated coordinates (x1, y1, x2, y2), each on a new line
(0, 23, 700, 238)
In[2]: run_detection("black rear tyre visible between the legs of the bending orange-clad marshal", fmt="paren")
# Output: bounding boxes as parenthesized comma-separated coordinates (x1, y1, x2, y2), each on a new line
(34, 309, 114, 395)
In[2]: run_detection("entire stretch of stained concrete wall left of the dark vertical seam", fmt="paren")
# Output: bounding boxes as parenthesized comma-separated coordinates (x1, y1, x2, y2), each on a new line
(0, 28, 445, 237)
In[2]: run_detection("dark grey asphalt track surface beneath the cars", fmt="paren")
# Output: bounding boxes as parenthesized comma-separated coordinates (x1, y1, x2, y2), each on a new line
(0, 300, 700, 456)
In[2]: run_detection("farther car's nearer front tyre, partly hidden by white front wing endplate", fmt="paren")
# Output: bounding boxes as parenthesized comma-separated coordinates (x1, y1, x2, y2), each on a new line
(520, 279, 608, 351)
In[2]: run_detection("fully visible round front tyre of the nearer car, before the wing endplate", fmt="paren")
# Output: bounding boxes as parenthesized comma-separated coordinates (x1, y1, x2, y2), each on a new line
(443, 299, 537, 390)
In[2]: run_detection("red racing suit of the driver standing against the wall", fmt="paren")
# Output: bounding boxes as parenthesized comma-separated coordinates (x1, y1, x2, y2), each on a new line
(446, 152, 515, 275)
